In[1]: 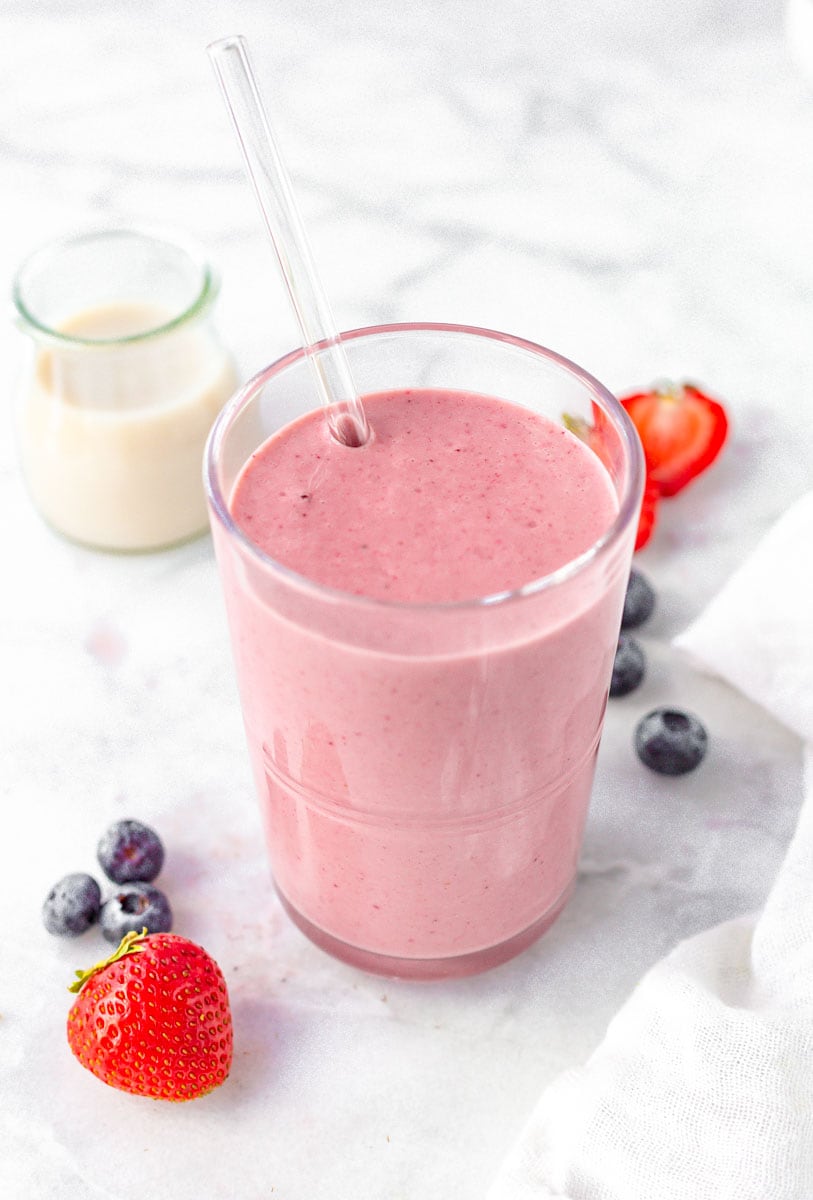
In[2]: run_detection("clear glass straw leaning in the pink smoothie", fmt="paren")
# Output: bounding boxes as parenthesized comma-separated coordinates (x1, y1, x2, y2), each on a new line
(207, 36, 369, 446)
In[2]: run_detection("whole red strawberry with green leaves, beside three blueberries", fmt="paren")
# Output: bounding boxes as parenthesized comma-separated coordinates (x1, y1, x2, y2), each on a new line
(67, 930, 233, 1100)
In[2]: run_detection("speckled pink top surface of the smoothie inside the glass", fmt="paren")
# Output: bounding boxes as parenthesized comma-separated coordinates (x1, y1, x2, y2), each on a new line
(230, 389, 618, 604)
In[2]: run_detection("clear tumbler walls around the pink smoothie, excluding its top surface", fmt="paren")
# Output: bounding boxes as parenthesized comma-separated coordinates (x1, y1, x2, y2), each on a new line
(205, 324, 643, 979)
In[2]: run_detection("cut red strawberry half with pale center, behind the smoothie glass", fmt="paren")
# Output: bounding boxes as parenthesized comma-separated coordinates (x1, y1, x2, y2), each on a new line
(621, 383, 728, 496)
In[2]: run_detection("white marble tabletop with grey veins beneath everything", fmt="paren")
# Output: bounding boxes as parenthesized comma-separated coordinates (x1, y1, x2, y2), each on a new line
(0, 0, 813, 1200)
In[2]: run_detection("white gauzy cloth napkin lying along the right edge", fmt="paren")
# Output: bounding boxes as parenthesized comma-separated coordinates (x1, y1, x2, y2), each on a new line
(488, 494, 813, 1200)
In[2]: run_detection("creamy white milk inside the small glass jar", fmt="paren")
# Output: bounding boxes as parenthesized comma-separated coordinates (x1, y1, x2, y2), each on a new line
(20, 304, 236, 550)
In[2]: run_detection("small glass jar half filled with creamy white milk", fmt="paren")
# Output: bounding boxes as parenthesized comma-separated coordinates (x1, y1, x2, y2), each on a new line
(13, 229, 236, 551)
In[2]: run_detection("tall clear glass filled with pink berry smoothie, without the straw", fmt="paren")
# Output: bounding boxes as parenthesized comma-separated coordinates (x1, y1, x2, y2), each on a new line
(205, 325, 643, 978)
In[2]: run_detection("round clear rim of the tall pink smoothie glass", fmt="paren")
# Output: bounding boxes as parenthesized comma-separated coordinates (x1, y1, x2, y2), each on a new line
(203, 322, 645, 613)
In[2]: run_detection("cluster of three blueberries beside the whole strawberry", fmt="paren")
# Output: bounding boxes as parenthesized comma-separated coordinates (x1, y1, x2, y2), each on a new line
(42, 820, 173, 946)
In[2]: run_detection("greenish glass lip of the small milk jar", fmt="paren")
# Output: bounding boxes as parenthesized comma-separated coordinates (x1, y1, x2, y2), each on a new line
(12, 226, 219, 348)
